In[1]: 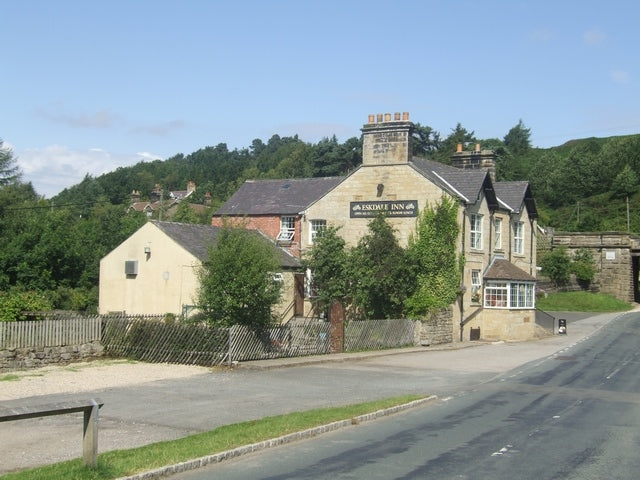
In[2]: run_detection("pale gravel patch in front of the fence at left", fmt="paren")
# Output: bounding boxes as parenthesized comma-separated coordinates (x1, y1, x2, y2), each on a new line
(0, 360, 211, 402)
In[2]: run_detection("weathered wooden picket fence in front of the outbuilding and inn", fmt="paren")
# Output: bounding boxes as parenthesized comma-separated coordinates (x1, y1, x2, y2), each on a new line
(0, 315, 415, 366)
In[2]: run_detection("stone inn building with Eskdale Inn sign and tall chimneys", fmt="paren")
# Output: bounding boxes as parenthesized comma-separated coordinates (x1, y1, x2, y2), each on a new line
(212, 113, 541, 343)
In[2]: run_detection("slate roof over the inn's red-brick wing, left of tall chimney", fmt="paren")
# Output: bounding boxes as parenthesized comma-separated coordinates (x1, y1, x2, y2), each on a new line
(214, 177, 344, 216)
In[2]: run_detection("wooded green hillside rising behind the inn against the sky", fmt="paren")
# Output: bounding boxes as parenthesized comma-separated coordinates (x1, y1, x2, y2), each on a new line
(52, 131, 640, 232)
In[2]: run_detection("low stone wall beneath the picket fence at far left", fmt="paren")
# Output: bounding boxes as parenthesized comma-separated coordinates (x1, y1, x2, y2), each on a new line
(0, 342, 103, 372)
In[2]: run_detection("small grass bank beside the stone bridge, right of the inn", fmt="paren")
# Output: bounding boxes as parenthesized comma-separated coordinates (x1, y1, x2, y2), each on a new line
(536, 292, 632, 312)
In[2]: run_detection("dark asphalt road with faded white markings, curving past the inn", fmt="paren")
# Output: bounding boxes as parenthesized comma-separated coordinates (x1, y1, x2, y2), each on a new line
(172, 313, 640, 480)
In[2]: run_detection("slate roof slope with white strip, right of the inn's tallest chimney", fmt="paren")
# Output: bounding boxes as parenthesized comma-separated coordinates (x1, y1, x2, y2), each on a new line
(411, 157, 498, 208)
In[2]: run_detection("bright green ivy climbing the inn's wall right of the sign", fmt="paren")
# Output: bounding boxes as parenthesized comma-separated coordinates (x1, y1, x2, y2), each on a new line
(406, 196, 463, 316)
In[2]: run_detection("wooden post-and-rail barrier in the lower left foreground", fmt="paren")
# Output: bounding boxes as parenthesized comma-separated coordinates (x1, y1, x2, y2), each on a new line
(0, 399, 104, 467)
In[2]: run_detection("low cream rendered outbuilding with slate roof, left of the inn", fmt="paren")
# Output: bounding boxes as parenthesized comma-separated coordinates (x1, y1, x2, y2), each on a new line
(99, 220, 300, 315)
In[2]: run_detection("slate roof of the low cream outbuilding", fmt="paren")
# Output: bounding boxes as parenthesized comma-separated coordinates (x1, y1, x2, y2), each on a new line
(151, 220, 300, 268)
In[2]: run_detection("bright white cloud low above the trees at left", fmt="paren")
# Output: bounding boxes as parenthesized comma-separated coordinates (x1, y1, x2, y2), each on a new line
(14, 145, 161, 198)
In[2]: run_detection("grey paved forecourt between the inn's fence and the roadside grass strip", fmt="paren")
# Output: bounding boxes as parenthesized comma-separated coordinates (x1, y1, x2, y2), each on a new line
(0, 314, 635, 478)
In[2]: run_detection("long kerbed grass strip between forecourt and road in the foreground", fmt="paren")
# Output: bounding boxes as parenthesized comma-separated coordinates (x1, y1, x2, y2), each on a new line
(1, 395, 424, 480)
